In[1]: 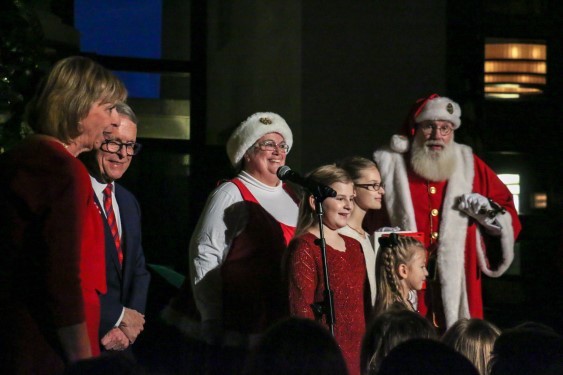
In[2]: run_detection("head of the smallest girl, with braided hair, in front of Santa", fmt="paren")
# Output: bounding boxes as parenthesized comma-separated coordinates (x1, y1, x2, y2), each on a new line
(374, 233, 428, 316)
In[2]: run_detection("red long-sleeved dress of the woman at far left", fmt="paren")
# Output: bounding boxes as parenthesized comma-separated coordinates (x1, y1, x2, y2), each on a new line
(0, 136, 106, 374)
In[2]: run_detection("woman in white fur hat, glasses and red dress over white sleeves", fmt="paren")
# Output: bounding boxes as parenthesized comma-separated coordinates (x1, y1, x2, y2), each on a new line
(163, 112, 298, 346)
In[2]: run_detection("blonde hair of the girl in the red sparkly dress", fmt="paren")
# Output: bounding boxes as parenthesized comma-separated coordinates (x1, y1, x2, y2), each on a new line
(295, 164, 352, 237)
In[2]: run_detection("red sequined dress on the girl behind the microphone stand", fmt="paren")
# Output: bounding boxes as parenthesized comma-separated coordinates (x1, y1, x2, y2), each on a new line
(287, 233, 368, 375)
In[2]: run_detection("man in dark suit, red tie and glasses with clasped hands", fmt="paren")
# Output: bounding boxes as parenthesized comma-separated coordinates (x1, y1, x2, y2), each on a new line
(83, 104, 150, 350)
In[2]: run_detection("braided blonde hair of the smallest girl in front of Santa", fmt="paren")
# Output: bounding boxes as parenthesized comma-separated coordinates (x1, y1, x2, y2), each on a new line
(374, 233, 425, 315)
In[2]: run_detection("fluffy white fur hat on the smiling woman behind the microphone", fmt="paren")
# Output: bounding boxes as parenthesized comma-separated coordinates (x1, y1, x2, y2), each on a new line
(227, 112, 293, 167)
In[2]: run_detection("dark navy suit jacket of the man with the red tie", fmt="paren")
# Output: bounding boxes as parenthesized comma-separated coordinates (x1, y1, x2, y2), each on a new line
(98, 183, 150, 339)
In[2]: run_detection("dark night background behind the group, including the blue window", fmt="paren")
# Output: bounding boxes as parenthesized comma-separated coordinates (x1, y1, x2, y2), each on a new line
(0, 0, 563, 340)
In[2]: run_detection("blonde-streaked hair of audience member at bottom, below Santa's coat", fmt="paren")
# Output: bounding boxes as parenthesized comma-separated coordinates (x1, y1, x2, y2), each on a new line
(442, 318, 500, 375)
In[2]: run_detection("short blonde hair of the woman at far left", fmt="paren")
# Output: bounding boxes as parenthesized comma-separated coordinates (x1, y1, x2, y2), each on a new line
(27, 56, 127, 143)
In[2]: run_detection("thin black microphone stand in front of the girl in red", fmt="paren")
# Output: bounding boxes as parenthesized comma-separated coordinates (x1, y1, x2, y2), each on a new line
(311, 191, 334, 336)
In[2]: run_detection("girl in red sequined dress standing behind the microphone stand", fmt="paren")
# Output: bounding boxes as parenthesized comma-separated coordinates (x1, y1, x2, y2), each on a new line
(286, 165, 369, 374)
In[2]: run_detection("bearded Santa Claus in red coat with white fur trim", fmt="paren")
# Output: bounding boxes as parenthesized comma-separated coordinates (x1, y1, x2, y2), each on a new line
(365, 94, 521, 329)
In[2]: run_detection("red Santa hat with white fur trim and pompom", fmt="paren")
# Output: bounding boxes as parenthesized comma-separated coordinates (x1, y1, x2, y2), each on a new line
(391, 94, 461, 153)
